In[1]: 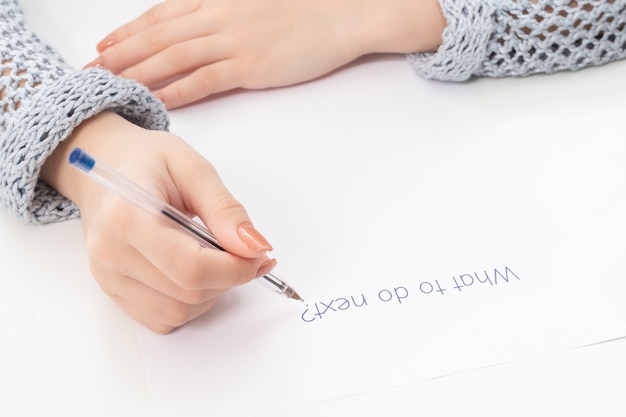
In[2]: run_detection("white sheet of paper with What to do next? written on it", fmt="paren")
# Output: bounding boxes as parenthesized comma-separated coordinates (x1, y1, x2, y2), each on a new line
(140, 58, 626, 417)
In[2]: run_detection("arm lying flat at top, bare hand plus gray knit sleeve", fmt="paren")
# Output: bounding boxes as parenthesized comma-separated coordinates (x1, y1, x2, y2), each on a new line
(89, 0, 626, 108)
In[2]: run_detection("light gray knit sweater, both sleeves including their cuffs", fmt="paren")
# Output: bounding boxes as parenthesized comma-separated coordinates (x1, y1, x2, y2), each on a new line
(0, 0, 626, 223)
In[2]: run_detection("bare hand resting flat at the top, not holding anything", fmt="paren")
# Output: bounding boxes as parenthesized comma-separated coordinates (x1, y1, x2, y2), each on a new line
(87, 0, 445, 109)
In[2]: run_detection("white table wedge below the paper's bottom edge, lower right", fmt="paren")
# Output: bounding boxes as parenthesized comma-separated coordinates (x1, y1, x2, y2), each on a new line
(266, 339, 626, 417)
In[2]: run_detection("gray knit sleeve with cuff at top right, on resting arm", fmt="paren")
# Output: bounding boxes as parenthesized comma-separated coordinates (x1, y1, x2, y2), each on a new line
(408, 0, 626, 81)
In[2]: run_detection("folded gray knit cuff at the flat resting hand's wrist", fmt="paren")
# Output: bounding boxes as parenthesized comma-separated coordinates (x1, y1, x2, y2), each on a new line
(407, 0, 496, 81)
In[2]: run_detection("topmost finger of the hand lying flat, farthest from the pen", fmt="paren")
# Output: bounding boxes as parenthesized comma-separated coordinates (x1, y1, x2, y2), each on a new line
(96, 0, 201, 53)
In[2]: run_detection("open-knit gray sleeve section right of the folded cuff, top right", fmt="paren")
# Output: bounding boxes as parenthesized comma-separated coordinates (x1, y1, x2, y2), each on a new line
(476, 0, 626, 76)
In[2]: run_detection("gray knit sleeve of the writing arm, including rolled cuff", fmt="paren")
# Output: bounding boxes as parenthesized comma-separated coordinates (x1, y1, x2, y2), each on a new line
(0, 0, 168, 223)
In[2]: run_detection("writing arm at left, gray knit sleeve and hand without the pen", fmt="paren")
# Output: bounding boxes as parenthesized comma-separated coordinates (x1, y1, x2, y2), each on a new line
(0, 1, 276, 333)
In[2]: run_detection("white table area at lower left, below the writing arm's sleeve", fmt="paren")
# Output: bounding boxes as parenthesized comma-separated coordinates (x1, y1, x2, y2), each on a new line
(0, 210, 151, 417)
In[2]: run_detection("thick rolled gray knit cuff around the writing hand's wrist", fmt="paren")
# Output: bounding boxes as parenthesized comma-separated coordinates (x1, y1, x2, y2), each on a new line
(0, 69, 168, 223)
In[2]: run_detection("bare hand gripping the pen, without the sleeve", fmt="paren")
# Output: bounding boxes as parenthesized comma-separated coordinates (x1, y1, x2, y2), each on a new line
(41, 112, 276, 333)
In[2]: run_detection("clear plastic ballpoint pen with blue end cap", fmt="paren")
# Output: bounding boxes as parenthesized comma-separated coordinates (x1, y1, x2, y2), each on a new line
(69, 148, 303, 301)
